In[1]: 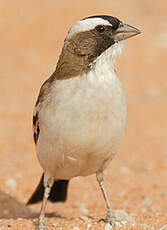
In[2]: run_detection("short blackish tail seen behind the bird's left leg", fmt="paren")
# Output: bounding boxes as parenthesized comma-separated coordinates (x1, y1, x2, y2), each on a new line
(27, 174, 69, 205)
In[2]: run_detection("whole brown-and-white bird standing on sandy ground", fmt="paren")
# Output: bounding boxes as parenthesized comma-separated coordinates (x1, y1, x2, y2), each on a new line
(27, 15, 141, 230)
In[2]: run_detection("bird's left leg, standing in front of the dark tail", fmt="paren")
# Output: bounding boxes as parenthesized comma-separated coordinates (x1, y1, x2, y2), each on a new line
(37, 174, 54, 230)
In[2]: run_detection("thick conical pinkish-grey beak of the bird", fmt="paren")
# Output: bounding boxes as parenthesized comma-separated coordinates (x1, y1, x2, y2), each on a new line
(114, 23, 141, 42)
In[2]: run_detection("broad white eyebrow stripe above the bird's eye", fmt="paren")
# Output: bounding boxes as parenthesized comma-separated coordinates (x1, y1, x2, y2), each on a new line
(66, 17, 112, 39)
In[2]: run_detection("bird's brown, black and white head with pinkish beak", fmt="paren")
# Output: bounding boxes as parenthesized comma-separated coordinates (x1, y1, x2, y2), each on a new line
(57, 15, 140, 78)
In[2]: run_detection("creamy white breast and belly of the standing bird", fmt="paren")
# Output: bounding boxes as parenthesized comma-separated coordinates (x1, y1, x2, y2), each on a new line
(37, 43, 126, 179)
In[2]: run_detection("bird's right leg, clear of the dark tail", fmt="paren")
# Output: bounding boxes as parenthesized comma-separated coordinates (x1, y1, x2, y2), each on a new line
(96, 172, 115, 224)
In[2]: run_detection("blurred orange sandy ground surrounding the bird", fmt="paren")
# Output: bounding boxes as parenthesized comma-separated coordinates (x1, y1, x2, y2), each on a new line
(0, 0, 167, 230)
